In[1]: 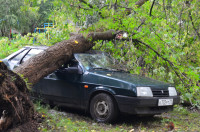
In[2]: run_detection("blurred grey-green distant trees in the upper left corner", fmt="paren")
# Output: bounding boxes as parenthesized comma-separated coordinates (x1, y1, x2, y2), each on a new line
(0, 0, 53, 37)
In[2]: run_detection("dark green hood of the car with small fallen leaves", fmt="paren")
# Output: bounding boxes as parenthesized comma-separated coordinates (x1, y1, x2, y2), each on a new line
(90, 70, 171, 88)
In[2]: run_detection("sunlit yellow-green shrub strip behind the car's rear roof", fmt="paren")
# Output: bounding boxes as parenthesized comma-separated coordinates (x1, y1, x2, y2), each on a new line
(0, 27, 71, 59)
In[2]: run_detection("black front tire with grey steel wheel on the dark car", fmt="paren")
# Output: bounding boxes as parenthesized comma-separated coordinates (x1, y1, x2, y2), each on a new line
(90, 93, 119, 123)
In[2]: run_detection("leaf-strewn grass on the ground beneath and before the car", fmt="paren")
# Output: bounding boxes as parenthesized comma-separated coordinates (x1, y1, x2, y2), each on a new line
(35, 103, 200, 132)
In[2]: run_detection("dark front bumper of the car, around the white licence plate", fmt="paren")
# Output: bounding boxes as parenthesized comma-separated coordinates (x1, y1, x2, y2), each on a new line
(115, 95, 180, 115)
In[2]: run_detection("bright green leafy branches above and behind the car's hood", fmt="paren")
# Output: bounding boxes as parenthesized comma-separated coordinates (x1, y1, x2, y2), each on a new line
(48, 0, 200, 107)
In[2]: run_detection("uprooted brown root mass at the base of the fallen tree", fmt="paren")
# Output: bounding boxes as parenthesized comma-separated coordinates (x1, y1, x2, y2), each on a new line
(0, 62, 34, 131)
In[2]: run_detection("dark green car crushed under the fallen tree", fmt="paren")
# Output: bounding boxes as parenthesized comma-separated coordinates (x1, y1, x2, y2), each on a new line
(4, 47, 180, 122)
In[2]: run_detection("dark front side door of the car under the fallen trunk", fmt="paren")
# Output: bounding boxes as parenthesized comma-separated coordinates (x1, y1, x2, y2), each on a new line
(35, 61, 83, 107)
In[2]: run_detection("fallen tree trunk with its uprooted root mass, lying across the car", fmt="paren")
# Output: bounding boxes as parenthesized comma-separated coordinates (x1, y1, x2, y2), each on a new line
(0, 30, 116, 131)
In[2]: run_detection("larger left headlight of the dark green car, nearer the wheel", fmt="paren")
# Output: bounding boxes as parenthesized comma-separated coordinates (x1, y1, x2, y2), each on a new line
(137, 87, 153, 97)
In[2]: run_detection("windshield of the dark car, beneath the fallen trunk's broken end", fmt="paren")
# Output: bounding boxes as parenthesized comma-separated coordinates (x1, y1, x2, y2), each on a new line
(75, 53, 124, 71)
